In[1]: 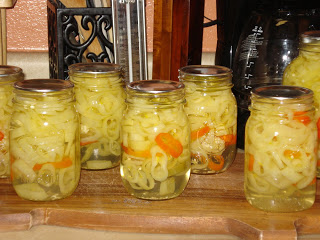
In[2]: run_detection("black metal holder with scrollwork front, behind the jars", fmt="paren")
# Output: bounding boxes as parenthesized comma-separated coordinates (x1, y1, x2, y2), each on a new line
(47, 0, 114, 79)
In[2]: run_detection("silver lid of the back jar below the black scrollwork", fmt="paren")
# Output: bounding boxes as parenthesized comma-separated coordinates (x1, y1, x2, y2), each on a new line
(68, 62, 122, 74)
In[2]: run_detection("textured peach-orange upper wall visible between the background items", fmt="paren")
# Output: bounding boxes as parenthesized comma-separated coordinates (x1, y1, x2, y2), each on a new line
(7, 0, 217, 52)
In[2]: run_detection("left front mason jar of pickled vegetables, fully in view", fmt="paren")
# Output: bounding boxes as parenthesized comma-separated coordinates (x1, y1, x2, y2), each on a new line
(10, 79, 81, 201)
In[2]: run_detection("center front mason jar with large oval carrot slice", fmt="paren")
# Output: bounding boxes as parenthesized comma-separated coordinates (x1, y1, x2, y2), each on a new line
(120, 80, 191, 200)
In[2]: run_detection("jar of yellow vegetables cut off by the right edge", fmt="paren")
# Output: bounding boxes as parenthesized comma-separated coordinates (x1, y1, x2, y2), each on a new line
(283, 31, 320, 177)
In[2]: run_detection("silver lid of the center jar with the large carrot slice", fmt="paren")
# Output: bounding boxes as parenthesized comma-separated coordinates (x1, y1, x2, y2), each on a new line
(127, 80, 184, 93)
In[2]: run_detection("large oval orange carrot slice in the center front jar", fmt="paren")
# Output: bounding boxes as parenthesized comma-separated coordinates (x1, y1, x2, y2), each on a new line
(155, 133, 183, 158)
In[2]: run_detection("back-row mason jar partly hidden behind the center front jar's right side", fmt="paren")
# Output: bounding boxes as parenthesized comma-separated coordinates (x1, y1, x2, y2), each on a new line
(179, 65, 237, 174)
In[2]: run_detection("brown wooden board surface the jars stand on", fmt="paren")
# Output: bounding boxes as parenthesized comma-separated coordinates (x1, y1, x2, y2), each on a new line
(0, 153, 320, 239)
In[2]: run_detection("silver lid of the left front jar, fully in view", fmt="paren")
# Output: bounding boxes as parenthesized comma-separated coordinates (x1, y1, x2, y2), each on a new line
(13, 79, 73, 93)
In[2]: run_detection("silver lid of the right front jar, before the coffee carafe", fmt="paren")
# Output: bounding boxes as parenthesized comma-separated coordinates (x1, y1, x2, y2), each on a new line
(251, 85, 313, 100)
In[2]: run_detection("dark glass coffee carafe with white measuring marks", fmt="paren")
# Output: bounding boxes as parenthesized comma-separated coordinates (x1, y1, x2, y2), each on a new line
(232, 1, 320, 149)
